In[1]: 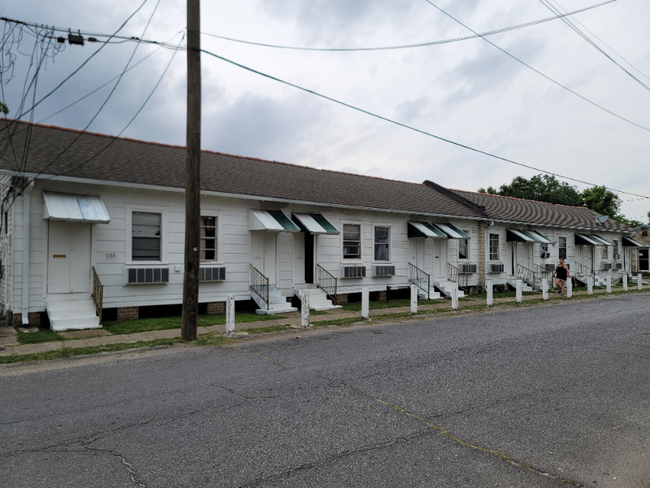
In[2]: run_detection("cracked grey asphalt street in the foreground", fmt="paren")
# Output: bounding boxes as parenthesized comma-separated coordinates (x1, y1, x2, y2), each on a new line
(0, 295, 650, 488)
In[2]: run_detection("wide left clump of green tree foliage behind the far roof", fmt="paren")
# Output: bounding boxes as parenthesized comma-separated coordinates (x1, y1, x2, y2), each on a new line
(478, 175, 582, 206)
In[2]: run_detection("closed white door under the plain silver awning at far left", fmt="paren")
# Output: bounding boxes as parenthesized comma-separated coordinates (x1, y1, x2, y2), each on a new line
(47, 221, 90, 293)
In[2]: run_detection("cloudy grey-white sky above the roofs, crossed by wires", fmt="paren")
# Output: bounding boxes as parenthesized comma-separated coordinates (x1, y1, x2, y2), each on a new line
(0, 0, 650, 221)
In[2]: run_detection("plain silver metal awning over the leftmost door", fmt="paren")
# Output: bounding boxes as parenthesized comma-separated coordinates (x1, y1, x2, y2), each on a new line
(43, 191, 111, 224)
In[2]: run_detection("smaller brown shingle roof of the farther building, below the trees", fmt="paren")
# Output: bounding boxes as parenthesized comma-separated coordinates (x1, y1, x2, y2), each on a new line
(452, 190, 632, 232)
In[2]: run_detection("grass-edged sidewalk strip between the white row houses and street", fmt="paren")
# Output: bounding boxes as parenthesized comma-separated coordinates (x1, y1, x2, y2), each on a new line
(0, 287, 650, 356)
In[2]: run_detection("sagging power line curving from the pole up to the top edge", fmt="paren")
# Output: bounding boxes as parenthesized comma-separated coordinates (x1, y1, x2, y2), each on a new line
(201, 0, 617, 52)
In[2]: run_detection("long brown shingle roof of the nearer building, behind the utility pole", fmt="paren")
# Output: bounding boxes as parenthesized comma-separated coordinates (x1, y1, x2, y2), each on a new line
(0, 122, 481, 218)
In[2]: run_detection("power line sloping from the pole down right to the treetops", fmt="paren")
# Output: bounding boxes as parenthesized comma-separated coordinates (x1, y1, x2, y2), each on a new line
(201, 49, 650, 199)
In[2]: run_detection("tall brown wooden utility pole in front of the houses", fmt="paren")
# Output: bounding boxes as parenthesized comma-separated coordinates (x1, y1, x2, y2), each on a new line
(181, 0, 201, 341)
